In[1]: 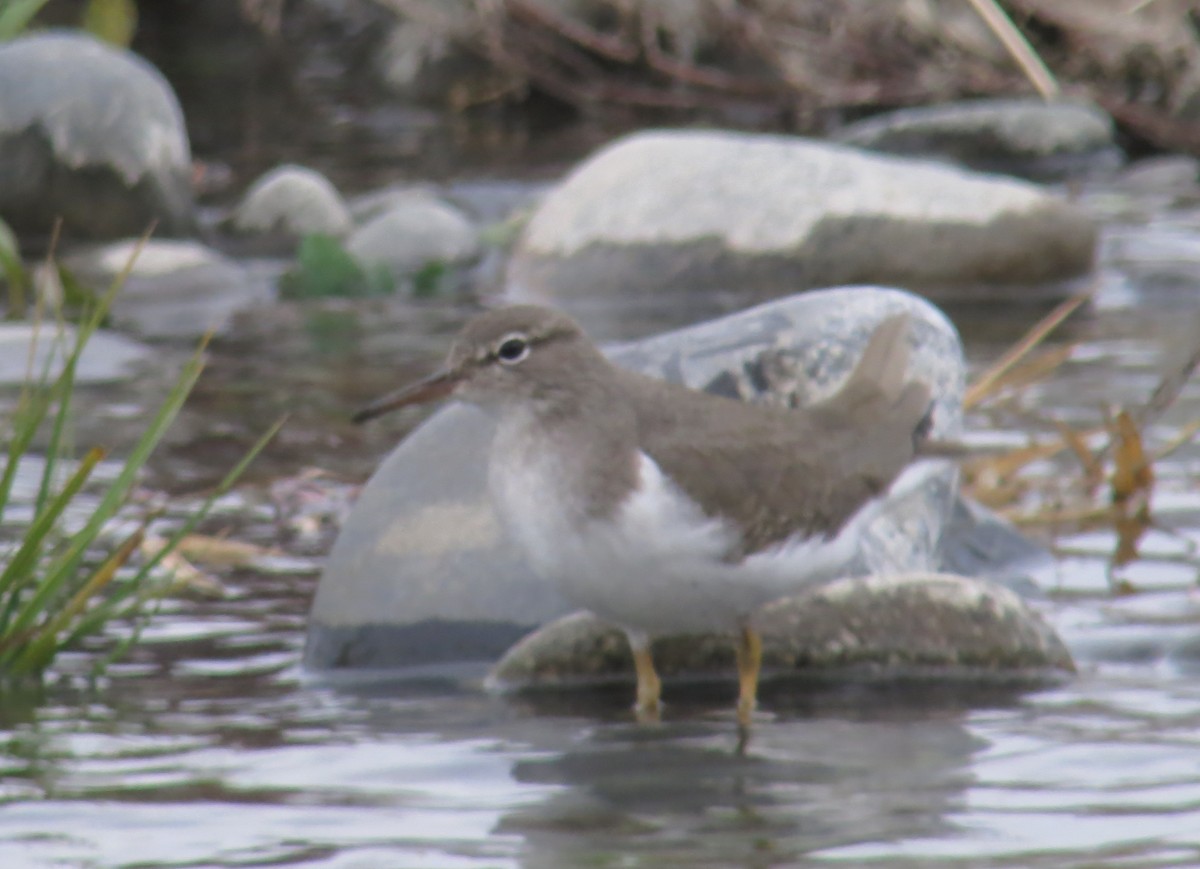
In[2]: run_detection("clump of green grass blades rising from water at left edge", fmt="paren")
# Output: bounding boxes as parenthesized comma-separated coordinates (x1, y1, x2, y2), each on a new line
(0, 238, 282, 678)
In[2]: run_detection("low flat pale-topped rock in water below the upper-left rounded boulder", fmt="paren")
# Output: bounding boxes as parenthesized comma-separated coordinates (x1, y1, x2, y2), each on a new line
(64, 239, 275, 337)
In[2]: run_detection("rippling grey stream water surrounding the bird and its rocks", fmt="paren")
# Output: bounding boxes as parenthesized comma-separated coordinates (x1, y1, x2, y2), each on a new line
(7, 172, 1200, 869)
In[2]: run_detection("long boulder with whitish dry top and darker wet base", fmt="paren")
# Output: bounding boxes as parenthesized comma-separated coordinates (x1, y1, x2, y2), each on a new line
(509, 132, 1096, 301)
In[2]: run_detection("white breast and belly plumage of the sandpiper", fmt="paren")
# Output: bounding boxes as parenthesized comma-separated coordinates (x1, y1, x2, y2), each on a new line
(490, 448, 859, 635)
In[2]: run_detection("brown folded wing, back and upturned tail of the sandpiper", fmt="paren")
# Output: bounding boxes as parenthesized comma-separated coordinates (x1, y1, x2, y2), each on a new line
(614, 316, 930, 559)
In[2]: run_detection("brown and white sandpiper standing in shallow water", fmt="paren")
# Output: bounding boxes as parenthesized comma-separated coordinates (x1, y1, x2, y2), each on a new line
(354, 305, 932, 726)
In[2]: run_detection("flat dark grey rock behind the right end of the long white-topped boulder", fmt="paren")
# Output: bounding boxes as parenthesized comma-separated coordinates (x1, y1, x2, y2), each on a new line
(836, 97, 1123, 179)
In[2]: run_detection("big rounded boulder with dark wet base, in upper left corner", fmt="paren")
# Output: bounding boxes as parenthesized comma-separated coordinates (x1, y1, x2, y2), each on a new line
(0, 31, 193, 239)
